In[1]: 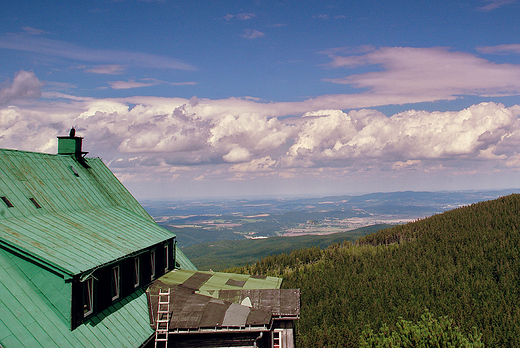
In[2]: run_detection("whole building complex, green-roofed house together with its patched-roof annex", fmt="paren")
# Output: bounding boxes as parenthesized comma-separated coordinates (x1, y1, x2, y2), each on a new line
(0, 129, 300, 348)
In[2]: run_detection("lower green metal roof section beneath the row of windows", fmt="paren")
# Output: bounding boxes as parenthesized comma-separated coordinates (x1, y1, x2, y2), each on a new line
(0, 248, 154, 348)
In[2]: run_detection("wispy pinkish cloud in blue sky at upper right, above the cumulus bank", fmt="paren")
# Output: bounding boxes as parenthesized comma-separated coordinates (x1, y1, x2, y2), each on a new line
(327, 47, 520, 99)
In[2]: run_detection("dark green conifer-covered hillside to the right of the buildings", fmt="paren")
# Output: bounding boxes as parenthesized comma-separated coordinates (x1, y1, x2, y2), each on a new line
(229, 195, 520, 347)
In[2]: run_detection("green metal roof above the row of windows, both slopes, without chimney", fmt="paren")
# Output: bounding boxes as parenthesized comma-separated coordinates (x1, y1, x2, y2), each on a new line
(0, 149, 186, 275)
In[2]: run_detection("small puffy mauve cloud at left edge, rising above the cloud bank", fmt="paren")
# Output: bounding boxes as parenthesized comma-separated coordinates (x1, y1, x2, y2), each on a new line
(0, 70, 43, 104)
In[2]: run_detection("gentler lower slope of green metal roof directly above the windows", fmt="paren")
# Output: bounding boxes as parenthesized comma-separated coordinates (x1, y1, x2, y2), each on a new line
(0, 207, 172, 275)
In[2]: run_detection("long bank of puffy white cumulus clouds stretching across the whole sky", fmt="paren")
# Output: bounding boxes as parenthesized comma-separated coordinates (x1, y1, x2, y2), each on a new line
(4, 91, 520, 177)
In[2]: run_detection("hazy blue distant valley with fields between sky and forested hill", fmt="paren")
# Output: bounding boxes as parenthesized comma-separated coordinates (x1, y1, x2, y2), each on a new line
(141, 189, 520, 248)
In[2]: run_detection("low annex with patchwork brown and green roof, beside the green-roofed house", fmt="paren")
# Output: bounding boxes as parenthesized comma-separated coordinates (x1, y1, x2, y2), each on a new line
(147, 270, 300, 348)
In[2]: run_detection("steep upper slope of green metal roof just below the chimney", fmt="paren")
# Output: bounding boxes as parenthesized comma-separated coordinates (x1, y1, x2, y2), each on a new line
(0, 149, 153, 222)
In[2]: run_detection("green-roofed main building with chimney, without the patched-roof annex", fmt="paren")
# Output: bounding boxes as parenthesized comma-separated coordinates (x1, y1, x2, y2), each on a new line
(0, 131, 195, 348)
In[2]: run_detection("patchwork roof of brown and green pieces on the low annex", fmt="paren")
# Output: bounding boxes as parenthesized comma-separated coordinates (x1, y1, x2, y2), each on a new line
(147, 270, 300, 332)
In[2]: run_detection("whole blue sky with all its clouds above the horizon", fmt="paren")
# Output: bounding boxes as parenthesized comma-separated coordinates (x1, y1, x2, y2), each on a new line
(0, 0, 520, 199)
